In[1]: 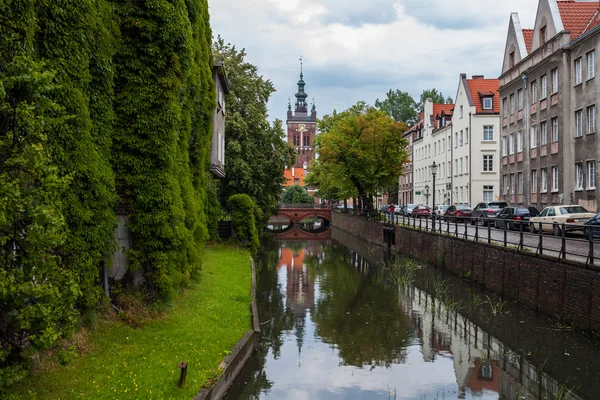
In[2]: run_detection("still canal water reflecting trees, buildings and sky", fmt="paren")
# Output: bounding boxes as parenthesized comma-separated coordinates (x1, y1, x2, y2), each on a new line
(226, 232, 600, 400)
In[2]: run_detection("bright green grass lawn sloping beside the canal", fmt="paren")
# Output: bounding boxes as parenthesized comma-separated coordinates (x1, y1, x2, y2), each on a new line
(14, 245, 251, 399)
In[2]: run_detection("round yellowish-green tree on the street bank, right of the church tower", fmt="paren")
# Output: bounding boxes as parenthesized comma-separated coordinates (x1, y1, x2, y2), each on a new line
(309, 102, 408, 210)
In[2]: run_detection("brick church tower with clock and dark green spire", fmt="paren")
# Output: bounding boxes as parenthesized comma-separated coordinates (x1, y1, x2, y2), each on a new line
(283, 64, 317, 186)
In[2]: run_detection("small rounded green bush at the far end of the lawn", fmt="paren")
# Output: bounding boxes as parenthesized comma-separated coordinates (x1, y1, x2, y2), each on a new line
(227, 194, 262, 253)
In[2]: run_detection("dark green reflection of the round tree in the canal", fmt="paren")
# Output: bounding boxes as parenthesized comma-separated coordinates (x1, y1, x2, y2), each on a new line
(305, 242, 410, 367)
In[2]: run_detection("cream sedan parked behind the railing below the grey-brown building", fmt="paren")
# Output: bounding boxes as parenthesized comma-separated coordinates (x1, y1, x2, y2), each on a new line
(529, 205, 596, 236)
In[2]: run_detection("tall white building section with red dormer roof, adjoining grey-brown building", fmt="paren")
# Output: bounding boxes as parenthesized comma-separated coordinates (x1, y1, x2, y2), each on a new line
(452, 74, 500, 207)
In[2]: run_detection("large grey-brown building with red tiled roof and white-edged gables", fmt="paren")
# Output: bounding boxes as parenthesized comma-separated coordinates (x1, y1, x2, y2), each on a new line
(500, 0, 600, 211)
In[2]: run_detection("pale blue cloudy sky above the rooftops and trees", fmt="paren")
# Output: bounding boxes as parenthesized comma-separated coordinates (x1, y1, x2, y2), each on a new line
(208, 0, 538, 120)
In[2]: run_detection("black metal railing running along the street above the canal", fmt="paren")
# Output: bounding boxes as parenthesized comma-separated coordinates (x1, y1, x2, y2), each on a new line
(348, 210, 600, 266)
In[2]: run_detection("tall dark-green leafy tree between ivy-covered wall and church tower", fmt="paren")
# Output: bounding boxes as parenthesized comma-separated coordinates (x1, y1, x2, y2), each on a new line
(213, 37, 295, 230)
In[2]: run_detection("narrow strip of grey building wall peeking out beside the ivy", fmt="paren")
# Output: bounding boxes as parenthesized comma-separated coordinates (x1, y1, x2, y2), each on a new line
(210, 62, 229, 178)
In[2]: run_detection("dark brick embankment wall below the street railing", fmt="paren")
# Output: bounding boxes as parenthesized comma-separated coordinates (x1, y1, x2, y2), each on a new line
(332, 213, 600, 336)
